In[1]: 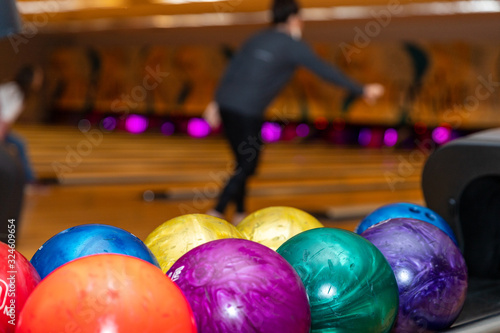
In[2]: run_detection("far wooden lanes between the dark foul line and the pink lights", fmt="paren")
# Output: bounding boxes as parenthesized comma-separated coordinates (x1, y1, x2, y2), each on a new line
(13, 127, 424, 187)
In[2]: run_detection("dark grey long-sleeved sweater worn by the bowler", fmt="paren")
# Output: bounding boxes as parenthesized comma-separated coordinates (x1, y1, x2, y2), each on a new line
(215, 28, 363, 117)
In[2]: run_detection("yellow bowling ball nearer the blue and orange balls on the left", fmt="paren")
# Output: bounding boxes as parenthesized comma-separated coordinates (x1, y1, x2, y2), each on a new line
(145, 214, 245, 273)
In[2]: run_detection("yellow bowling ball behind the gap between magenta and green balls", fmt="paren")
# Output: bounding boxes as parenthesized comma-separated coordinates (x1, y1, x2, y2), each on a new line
(236, 207, 324, 250)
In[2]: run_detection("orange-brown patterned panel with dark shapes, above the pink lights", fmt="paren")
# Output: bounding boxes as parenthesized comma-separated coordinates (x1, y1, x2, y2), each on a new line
(39, 42, 500, 128)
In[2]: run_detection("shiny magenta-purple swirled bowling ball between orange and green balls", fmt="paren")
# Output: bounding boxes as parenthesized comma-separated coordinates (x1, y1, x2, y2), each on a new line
(168, 239, 311, 333)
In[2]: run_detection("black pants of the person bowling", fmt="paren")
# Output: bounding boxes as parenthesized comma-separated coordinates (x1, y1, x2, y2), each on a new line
(215, 108, 263, 213)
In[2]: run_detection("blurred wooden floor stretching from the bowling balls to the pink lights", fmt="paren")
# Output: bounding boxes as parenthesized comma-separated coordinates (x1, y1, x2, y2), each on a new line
(16, 126, 425, 258)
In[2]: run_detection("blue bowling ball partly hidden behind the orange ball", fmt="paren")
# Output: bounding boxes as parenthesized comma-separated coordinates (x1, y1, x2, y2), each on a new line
(31, 224, 160, 279)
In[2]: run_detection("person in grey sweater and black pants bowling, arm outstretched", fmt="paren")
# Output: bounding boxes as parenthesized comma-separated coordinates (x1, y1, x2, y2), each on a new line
(204, 0, 384, 225)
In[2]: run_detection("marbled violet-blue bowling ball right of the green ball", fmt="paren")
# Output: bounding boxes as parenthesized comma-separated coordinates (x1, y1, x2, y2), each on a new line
(361, 218, 467, 333)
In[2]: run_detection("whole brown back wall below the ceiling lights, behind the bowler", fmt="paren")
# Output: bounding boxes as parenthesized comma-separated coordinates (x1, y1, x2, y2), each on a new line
(0, 18, 500, 130)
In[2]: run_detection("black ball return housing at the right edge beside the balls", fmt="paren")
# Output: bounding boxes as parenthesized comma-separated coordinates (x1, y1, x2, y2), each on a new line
(422, 129, 500, 333)
